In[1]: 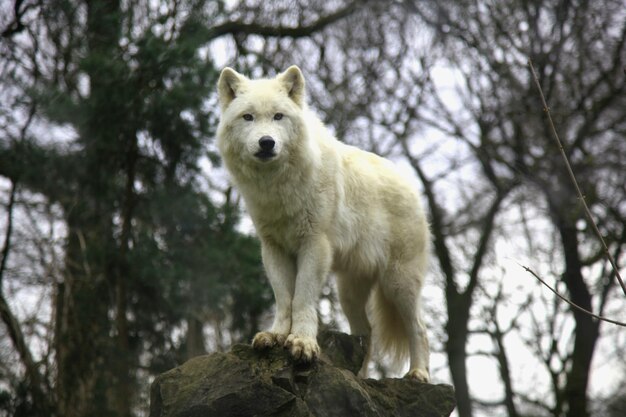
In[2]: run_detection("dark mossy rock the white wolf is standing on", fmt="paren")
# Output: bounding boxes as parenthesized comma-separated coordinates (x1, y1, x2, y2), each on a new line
(150, 332, 455, 417)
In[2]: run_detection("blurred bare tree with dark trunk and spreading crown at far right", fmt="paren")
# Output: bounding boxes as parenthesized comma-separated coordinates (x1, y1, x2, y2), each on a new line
(410, 0, 626, 417)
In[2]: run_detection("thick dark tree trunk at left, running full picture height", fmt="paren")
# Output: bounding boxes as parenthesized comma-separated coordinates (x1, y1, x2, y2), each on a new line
(57, 0, 126, 417)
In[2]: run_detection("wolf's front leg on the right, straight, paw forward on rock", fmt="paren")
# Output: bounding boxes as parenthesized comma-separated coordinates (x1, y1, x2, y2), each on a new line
(285, 235, 332, 362)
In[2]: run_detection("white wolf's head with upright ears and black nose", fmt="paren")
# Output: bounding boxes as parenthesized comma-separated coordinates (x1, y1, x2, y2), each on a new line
(217, 65, 305, 164)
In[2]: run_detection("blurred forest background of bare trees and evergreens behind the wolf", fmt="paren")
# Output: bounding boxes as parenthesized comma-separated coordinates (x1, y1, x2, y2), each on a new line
(0, 0, 626, 417)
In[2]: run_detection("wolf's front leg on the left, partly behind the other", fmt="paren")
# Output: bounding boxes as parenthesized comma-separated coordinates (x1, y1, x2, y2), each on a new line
(252, 242, 296, 349)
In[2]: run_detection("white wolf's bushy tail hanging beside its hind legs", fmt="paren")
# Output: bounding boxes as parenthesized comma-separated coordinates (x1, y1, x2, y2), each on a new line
(368, 284, 409, 370)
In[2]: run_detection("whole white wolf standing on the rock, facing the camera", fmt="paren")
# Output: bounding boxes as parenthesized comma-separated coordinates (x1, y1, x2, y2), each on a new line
(217, 66, 430, 382)
